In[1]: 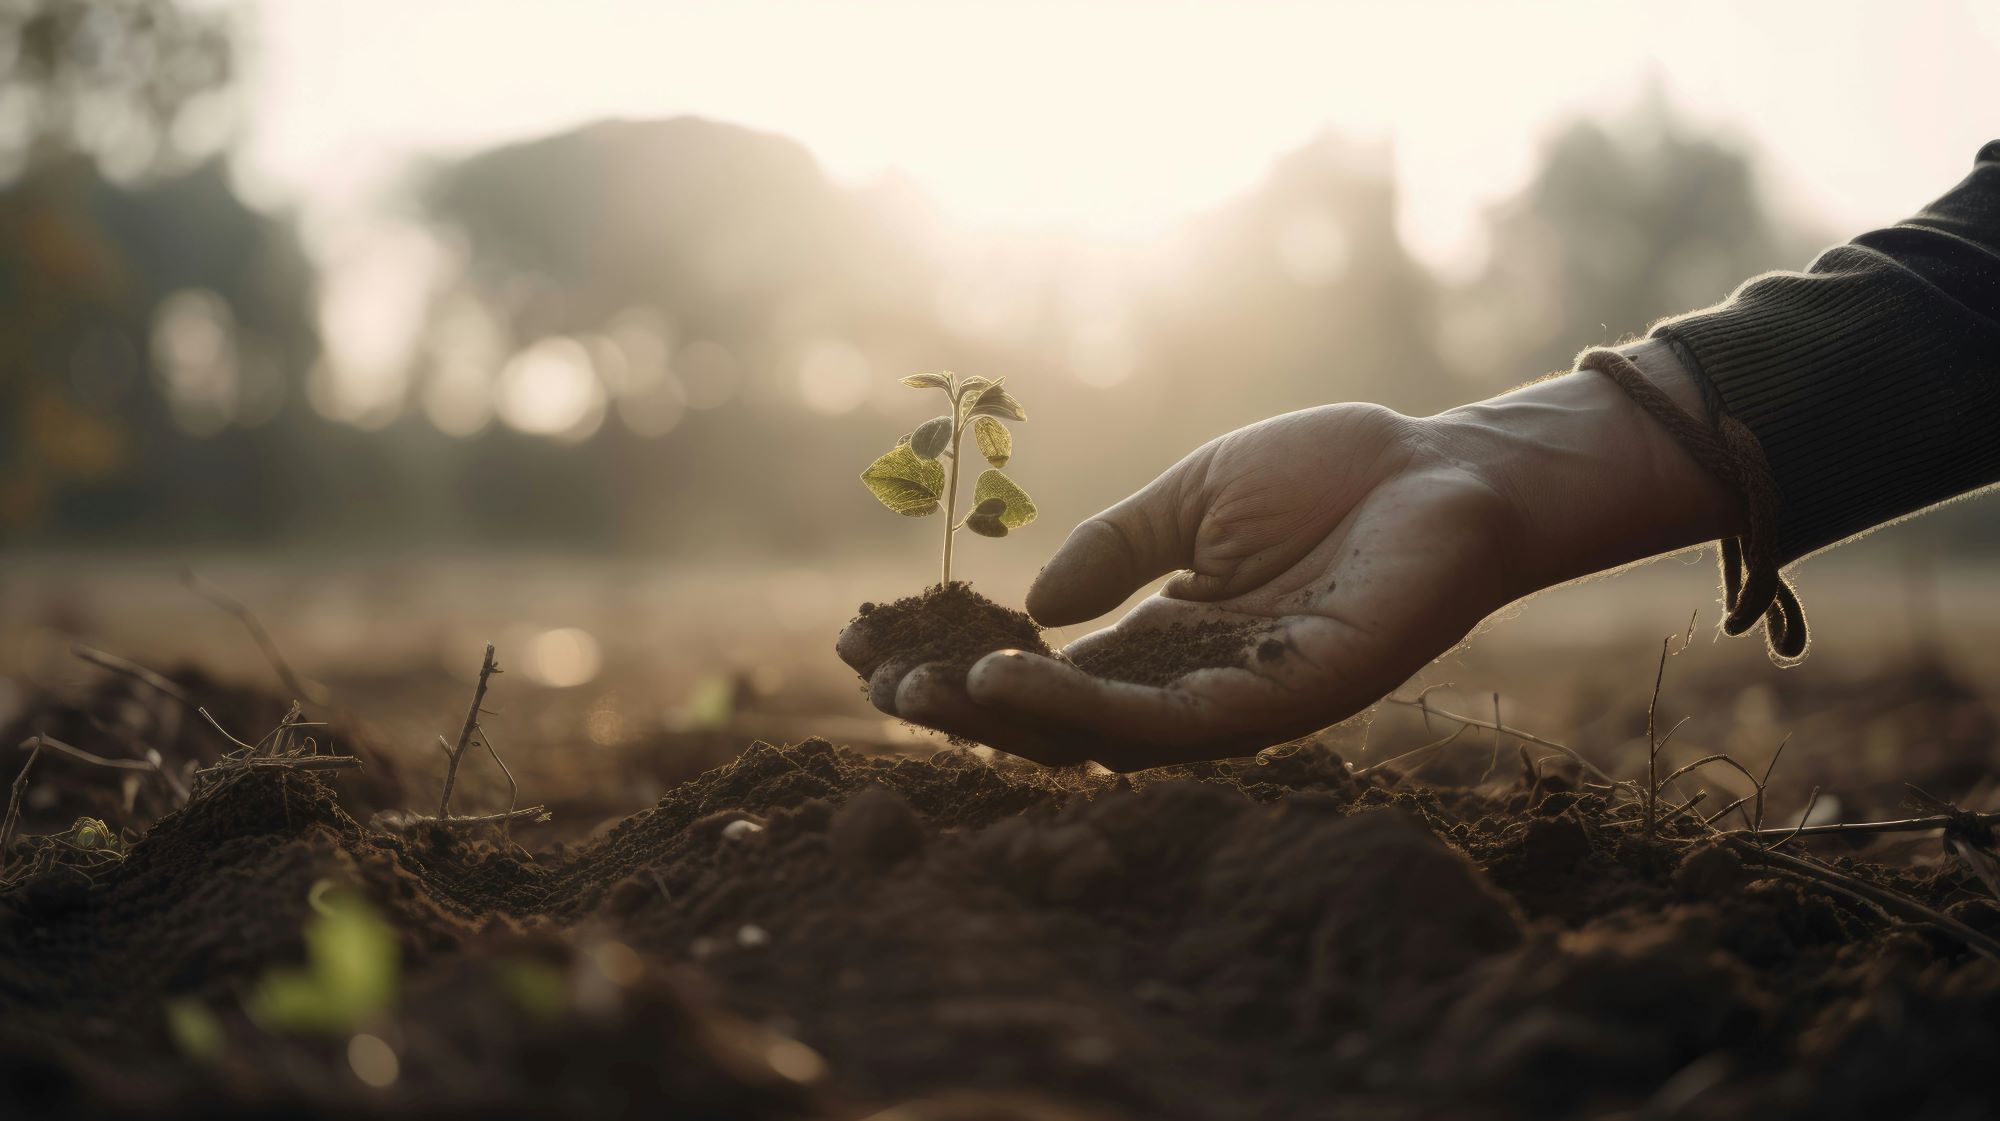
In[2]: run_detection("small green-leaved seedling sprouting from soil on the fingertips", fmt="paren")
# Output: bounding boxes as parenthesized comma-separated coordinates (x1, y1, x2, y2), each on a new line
(862, 372, 1036, 585)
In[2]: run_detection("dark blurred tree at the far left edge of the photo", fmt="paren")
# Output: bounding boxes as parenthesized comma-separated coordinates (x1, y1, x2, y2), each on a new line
(0, 0, 328, 540)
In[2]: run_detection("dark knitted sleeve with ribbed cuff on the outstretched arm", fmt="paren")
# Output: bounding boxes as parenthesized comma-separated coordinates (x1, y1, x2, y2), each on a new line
(1654, 140, 2000, 563)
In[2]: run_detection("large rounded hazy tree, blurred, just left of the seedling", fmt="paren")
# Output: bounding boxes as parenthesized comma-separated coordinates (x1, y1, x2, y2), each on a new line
(416, 118, 954, 550)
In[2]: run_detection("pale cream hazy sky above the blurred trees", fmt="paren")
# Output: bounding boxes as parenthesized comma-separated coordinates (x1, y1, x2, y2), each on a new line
(244, 0, 2000, 272)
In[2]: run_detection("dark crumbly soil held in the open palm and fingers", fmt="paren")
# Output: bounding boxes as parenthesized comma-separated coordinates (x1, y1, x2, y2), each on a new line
(856, 581, 1284, 685)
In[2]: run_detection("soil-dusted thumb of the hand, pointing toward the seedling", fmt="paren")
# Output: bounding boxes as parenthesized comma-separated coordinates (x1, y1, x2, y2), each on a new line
(1028, 452, 1200, 627)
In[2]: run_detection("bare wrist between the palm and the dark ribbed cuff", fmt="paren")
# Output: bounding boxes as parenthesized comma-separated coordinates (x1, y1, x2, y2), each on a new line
(1432, 340, 1744, 595)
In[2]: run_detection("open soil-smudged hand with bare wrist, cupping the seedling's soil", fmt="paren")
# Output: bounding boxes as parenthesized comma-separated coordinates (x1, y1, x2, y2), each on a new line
(838, 344, 1742, 771)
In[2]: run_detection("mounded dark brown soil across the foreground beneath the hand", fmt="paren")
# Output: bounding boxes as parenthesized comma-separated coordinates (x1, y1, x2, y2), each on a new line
(0, 716, 2000, 1119)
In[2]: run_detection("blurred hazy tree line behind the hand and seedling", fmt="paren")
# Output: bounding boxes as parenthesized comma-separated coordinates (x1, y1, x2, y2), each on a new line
(0, 0, 1942, 556)
